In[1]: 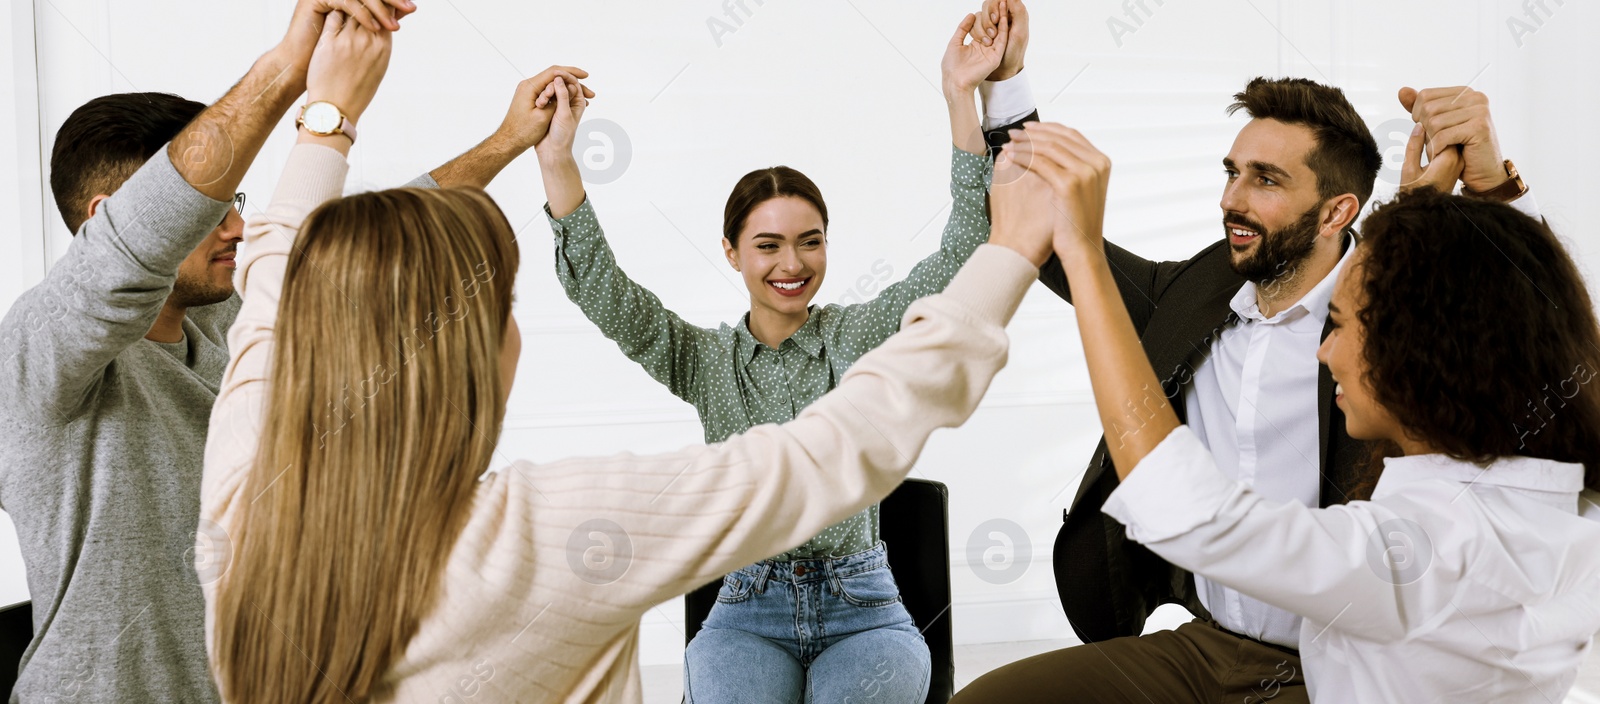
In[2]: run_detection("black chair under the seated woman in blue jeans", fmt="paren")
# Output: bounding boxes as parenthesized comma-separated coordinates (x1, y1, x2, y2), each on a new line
(683, 478, 955, 704)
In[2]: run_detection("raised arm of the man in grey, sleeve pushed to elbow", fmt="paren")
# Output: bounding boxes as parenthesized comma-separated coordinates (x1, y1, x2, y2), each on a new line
(0, 0, 411, 422)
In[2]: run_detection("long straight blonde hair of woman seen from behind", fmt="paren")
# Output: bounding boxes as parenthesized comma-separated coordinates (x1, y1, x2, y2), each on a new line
(213, 189, 518, 704)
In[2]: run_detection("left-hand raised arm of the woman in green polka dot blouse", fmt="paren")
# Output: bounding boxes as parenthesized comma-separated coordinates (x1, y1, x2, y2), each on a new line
(536, 75, 715, 403)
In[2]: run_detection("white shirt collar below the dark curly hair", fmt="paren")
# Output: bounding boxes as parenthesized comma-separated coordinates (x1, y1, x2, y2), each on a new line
(1373, 454, 1584, 501)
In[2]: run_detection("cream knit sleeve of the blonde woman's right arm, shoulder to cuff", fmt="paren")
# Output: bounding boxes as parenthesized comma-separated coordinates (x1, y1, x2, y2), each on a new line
(512, 246, 1042, 622)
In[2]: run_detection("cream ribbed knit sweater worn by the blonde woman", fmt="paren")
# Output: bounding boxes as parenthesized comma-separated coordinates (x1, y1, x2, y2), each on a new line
(195, 144, 1038, 702)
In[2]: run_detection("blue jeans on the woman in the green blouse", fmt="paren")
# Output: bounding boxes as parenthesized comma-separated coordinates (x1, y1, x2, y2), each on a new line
(683, 542, 933, 704)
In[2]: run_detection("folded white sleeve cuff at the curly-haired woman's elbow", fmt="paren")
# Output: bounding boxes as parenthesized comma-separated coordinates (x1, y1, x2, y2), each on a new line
(1101, 426, 1243, 544)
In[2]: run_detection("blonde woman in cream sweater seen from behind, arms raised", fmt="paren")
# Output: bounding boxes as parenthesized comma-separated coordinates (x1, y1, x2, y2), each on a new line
(195, 11, 1050, 702)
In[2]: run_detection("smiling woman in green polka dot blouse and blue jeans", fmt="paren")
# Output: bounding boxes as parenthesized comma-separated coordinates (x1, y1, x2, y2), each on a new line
(538, 16, 1006, 704)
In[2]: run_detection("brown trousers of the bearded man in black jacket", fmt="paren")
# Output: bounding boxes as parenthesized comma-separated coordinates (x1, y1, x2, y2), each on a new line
(950, 621, 1309, 704)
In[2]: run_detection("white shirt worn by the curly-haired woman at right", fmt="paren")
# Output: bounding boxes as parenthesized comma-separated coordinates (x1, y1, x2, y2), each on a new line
(1104, 427, 1600, 704)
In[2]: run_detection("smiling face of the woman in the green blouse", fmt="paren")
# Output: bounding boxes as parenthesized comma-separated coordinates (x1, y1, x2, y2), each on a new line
(722, 197, 827, 317)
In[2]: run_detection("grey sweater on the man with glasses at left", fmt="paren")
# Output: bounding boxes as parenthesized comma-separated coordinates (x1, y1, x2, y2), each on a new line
(0, 149, 437, 702)
